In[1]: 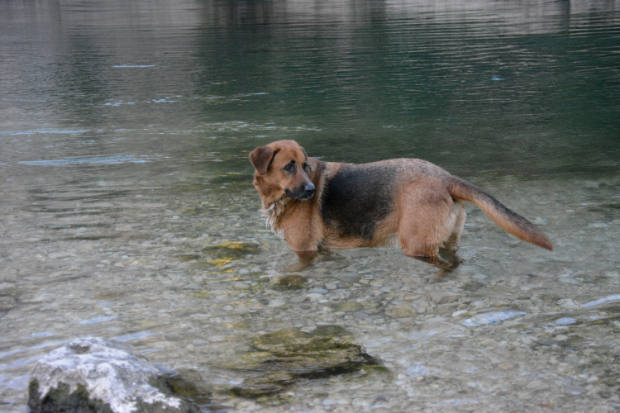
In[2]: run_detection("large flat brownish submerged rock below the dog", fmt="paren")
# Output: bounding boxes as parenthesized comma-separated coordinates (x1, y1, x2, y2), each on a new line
(227, 326, 380, 398)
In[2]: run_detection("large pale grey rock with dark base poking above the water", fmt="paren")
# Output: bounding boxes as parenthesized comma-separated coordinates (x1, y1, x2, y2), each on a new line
(28, 337, 197, 413)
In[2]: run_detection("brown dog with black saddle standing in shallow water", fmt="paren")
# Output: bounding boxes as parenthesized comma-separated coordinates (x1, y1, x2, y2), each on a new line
(250, 141, 553, 266)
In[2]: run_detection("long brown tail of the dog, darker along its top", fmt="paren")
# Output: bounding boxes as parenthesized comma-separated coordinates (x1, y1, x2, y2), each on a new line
(446, 177, 553, 251)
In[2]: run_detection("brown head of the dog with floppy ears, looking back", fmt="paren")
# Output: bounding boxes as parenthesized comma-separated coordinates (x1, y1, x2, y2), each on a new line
(250, 141, 316, 204)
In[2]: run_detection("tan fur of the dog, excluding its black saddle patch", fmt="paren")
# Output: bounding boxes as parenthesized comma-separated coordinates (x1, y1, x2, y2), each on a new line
(250, 141, 553, 257)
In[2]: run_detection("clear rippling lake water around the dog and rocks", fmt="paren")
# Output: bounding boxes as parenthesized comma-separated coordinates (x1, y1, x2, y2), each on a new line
(0, 0, 620, 412)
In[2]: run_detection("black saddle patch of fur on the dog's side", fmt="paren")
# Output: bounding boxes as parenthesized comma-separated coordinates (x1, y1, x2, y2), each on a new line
(321, 165, 396, 240)
